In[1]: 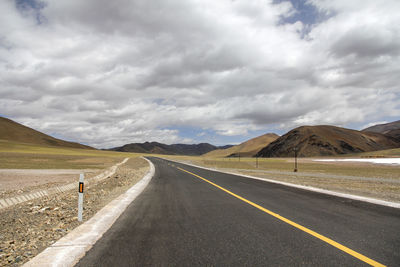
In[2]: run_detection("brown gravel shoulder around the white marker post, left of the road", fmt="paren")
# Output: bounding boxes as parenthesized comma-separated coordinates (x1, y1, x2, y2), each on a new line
(0, 158, 149, 266)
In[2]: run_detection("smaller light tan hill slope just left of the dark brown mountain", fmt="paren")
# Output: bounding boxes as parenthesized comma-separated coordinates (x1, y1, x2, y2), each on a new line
(204, 133, 279, 157)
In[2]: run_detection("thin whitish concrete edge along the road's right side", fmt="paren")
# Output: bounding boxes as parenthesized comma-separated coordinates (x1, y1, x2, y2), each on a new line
(163, 158, 400, 209)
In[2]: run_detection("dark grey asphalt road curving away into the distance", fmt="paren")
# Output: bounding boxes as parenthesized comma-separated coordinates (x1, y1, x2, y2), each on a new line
(77, 158, 400, 266)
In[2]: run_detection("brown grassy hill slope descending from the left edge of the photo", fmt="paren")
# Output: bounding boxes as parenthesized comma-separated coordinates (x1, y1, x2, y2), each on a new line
(0, 117, 94, 149)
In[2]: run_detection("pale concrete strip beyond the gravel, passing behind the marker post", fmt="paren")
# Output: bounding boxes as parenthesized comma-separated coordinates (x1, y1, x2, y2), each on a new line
(0, 158, 129, 209)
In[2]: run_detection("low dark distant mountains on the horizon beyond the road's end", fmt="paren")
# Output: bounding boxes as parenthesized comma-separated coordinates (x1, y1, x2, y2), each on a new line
(109, 142, 234, 156)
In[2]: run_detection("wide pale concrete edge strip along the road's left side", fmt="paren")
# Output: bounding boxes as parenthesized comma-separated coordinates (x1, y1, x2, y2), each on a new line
(24, 159, 155, 267)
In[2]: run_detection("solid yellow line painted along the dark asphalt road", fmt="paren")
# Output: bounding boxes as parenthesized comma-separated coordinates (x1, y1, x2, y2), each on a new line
(178, 167, 385, 266)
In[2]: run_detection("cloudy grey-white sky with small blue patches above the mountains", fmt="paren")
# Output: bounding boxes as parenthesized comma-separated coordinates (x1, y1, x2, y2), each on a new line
(0, 0, 400, 148)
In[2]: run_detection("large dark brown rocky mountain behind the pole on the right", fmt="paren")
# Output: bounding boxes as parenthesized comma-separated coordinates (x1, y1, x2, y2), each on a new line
(257, 125, 400, 157)
